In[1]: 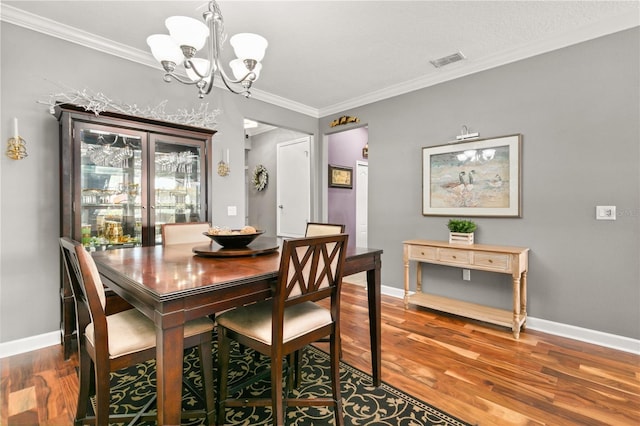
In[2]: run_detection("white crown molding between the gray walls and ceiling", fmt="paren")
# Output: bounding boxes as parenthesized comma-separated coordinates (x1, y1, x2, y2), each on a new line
(0, 4, 640, 118)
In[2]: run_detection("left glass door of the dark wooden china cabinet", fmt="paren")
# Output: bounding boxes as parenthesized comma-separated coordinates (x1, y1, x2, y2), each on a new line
(74, 123, 146, 249)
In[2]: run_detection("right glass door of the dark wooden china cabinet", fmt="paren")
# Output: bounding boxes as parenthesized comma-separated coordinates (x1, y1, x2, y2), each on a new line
(149, 134, 207, 244)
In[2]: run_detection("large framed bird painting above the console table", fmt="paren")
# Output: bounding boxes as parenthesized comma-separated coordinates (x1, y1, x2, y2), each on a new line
(422, 134, 522, 217)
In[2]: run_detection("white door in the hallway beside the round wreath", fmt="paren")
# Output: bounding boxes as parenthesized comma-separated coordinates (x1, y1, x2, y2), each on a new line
(276, 136, 311, 237)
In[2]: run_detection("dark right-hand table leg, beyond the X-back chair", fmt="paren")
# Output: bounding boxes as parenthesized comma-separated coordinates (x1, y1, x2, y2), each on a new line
(367, 256, 382, 386)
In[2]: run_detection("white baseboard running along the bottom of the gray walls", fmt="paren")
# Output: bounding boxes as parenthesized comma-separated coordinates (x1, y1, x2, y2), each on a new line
(0, 285, 640, 358)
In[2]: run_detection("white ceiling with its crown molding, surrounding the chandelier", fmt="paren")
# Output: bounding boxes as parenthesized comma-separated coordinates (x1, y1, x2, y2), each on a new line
(2, 0, 640, 117)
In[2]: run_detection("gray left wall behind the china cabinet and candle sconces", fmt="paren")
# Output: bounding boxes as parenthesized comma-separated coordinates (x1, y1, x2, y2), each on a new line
(0, 22, 318, 342)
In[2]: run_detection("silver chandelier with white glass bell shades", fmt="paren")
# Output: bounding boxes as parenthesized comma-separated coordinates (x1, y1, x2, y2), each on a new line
(147, 1, 268, 99)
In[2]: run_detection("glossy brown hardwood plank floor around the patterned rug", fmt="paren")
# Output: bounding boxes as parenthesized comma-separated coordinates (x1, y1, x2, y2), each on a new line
(0, 284, 640, 425)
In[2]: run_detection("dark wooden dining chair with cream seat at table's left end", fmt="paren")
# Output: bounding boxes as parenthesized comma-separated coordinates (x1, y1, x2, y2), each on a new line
(60, 237, 215, 425)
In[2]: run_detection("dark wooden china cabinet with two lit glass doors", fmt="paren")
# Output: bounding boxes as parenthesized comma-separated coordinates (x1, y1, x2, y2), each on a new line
(55, 104, 215, 358)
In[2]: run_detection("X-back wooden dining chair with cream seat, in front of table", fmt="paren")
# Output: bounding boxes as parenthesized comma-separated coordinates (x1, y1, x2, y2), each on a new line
(216, 234, 348, 426)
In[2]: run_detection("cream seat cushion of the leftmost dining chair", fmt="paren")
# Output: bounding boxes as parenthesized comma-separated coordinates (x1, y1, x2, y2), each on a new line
(85, 309, 213, 359)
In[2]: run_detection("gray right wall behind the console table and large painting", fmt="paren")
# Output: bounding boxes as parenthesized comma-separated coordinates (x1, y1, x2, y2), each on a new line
(320, 28, 640, 339)
